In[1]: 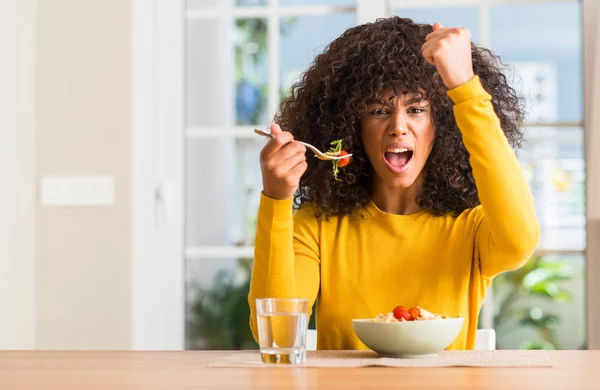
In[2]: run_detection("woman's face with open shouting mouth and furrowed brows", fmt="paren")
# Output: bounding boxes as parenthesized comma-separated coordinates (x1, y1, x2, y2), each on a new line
(360, 87, 435, 189)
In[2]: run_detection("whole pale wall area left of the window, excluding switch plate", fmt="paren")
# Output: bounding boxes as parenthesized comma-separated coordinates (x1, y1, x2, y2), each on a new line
(0, 0, 184, 349)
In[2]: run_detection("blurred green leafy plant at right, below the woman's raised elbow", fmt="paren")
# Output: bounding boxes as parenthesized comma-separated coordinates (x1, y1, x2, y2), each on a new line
(493, 256, 572, 349)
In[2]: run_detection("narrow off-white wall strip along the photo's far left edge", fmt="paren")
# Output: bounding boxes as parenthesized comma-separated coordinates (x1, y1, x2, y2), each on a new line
(0, 0, 35, 349)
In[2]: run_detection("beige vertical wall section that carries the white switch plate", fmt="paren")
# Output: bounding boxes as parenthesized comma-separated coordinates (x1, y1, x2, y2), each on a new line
(34, 0, 132, 349)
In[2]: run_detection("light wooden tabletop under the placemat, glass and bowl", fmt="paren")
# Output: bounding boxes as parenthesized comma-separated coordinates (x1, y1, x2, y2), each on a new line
(0, 351, 600, 390)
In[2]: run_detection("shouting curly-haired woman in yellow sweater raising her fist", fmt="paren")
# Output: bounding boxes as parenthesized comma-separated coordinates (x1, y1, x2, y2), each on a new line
(249, 17, 539, 349)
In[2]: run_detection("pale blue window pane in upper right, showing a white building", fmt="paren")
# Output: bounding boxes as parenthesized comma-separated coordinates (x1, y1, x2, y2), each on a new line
(490, 2, 583, 121)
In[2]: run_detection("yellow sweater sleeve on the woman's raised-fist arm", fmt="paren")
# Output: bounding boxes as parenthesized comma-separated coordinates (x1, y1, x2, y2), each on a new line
(448, 76, 540, 278)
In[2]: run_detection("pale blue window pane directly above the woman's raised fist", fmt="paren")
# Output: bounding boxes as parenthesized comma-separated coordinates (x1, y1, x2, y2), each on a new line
(393, 7, 481, 42)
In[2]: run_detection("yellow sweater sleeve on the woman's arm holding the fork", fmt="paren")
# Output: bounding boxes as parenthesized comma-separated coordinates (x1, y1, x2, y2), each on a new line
(248, 194, 320, 342)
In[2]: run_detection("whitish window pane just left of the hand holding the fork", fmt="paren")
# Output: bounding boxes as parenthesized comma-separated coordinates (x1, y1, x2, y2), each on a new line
(186, 137, 265, 246)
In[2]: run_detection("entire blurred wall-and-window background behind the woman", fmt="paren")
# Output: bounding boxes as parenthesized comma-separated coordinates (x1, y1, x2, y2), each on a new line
(0, 0, 600, 349)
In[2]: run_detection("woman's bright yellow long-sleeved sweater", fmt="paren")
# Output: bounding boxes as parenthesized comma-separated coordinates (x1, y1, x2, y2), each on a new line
(248, 77, 539, 349)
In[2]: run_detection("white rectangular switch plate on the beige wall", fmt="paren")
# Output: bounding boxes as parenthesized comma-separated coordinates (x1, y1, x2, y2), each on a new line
(40, 176, 115, 207)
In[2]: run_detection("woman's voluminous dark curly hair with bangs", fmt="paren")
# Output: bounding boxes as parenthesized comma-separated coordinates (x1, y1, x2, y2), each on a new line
(275, 17, 524, 218)
